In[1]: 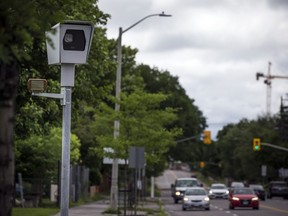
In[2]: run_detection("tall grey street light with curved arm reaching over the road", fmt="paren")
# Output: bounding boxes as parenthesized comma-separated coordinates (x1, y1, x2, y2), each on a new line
(110, 12, 172, 208)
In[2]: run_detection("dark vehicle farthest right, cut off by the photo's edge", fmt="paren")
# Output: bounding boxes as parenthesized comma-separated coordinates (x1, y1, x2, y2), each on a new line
(267, 181, 288, 199)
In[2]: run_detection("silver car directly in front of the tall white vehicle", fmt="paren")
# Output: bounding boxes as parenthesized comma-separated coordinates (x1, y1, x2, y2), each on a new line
(182, 187, 210, 211)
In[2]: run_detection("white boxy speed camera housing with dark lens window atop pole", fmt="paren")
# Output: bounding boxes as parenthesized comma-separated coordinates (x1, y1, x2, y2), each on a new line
(46, 21, 94, 65)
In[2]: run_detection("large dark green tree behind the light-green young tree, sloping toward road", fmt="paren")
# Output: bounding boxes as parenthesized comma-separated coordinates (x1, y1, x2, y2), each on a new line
(136, 64, 207, 162)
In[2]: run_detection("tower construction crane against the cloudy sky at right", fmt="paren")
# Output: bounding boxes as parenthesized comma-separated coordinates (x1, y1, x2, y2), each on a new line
(256, 62, 288, 117)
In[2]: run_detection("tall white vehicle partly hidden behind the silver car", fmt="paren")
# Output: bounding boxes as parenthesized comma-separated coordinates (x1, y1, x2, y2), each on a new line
(171, 178, 202, 203)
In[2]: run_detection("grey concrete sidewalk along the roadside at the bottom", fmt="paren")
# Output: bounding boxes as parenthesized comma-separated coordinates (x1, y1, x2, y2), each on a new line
(55, 198, 160, 216)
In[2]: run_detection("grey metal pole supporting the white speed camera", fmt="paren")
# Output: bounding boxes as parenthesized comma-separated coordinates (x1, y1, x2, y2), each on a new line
(60, 64, 75, 216)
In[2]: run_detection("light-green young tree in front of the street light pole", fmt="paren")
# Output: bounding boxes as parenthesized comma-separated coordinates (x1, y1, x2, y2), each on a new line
(95, 77, 181, 176)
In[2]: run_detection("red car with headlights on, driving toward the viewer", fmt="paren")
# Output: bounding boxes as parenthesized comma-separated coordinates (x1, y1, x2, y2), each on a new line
(229, 187, 259, 209)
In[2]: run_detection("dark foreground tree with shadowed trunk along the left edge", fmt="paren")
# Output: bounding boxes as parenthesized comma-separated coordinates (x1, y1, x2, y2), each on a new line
(0, 0, 67, 213)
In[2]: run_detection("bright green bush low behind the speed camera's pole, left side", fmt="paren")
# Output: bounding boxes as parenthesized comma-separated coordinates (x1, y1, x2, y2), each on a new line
(16, 128, 80, 178)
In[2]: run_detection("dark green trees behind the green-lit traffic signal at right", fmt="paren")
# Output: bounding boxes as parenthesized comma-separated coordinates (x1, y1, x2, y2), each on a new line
(217, 116, 288, 182)
